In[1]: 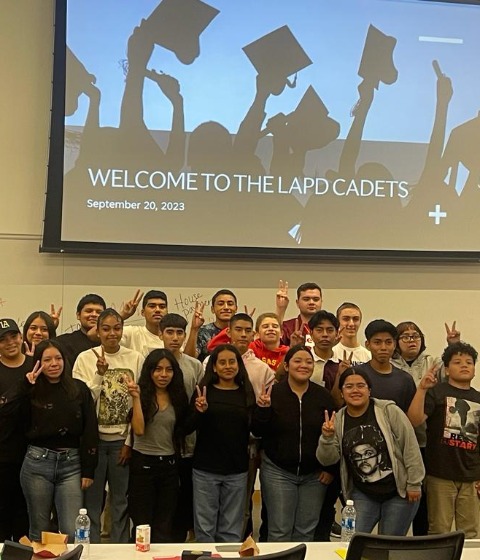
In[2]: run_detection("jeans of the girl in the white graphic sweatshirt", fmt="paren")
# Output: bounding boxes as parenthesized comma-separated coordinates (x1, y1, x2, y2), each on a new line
(85, 439, 130, 543)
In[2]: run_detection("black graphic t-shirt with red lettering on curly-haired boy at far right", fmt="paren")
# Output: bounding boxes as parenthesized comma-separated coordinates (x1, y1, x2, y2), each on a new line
(425, 382, 480, 482)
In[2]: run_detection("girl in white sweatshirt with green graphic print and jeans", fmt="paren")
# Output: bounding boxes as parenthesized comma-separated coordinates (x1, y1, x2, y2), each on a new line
(73, 308, 143, 543)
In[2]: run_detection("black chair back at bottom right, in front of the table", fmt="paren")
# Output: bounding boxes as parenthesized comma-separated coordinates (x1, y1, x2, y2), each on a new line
(345, 531, 465, 560)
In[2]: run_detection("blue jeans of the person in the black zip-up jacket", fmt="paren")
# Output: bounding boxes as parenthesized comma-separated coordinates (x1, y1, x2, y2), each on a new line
(260, 453, 327, 542)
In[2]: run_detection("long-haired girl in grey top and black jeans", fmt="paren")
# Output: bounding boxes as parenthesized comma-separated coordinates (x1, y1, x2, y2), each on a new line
(127, 349, 188, 542)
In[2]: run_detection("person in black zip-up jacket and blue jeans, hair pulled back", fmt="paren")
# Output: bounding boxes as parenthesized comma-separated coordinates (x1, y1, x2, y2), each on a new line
(252, 345, 334, 542)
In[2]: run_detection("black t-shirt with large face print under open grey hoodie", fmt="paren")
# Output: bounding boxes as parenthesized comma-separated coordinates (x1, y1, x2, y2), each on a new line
(342, 402, 397, 502)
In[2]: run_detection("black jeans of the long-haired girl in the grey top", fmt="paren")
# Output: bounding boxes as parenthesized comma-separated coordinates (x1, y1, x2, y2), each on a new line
(128, 450, 179, 543)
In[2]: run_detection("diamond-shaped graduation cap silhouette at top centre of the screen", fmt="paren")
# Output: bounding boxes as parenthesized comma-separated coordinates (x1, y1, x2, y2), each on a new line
(243, 25, 312, 94)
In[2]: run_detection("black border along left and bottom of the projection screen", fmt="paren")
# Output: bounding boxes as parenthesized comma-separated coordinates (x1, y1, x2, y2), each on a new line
(39, 0, 480, 263)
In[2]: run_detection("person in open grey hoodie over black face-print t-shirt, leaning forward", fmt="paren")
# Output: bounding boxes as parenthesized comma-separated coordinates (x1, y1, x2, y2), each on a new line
(317, 367, 425, 536)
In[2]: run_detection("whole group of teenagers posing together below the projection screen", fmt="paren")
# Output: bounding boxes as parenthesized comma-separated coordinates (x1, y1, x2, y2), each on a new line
(0, 282, 480, 543)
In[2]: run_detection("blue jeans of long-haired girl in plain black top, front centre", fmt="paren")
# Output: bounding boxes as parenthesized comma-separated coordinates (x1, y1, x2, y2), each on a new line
(193, 469, 248, 542)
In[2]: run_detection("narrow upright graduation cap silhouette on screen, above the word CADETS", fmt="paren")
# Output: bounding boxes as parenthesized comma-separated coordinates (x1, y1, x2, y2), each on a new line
(358, 25, 398, 89)
